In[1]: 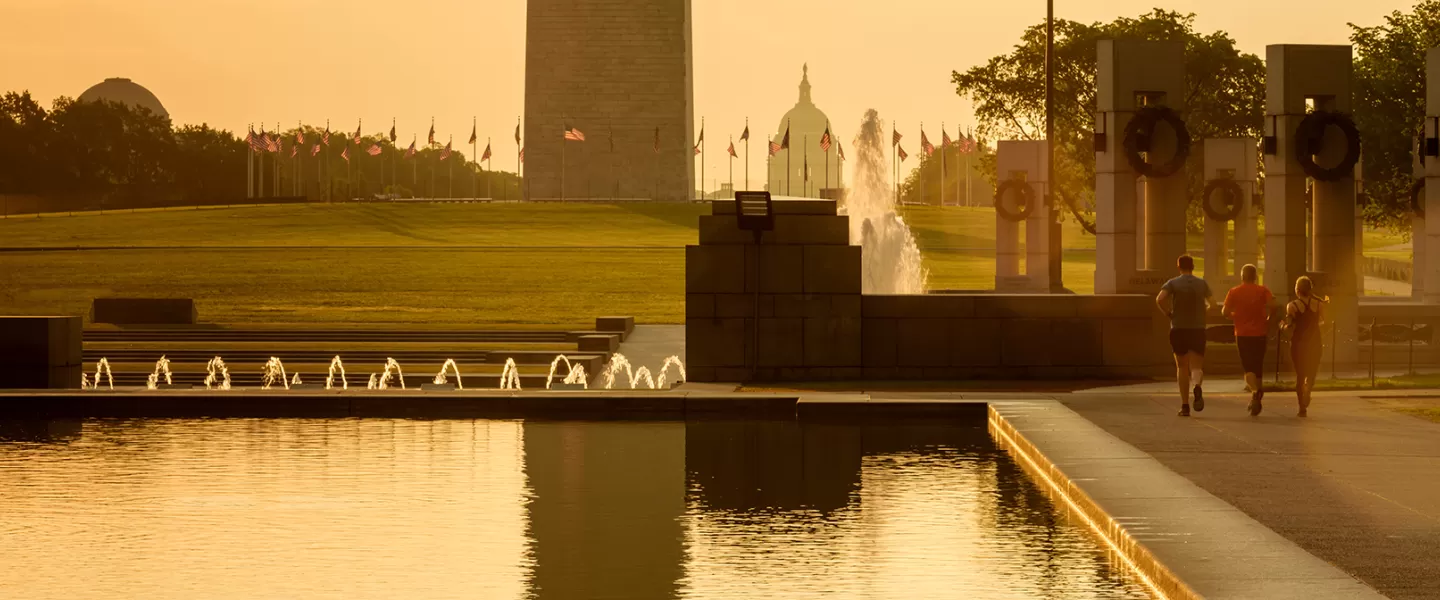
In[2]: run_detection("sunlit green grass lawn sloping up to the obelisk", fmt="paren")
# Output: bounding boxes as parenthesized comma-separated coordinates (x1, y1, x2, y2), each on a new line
(0, 203, 1416, 325)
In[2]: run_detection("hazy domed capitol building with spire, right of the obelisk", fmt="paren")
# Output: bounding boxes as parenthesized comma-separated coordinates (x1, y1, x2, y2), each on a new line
(768, 65, 844, 197)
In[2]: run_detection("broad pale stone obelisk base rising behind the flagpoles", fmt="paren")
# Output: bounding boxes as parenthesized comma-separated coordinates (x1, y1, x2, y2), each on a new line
(524, 0, 694, 200)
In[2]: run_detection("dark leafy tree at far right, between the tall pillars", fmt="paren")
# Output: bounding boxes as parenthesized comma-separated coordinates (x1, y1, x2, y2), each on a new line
(1351, 0, 1440, 229)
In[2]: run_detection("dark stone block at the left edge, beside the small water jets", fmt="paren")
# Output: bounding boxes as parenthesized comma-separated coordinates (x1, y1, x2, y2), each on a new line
(0, 317, 84, 390)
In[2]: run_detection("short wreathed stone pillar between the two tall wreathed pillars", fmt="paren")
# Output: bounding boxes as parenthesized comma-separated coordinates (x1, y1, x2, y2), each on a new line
(1202, 138, 1260, 294)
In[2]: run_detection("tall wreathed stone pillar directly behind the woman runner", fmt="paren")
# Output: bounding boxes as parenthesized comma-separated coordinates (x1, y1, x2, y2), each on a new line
(1264, 45, 1359, 364)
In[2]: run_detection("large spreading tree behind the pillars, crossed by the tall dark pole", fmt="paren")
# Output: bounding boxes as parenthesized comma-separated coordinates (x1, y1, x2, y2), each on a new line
(952, 9, 1264, 228)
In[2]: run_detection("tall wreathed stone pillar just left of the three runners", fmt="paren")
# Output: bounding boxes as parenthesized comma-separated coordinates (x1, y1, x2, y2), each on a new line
(1094, 40, 1189, 294)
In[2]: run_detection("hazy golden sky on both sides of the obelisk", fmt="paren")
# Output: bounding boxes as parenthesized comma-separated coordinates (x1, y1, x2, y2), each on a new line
(0, 0, 1413, 182)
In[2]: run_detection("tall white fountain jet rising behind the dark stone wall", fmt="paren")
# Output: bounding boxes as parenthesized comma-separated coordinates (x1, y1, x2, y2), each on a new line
(845, 108, 929, 294)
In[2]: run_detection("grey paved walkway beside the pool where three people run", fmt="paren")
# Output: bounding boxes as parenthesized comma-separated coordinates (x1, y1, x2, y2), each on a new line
(1057, 391, 1440, 600)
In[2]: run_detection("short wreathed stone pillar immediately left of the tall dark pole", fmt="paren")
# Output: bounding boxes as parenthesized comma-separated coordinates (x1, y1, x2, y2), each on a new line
(995, 140, 1050, 294)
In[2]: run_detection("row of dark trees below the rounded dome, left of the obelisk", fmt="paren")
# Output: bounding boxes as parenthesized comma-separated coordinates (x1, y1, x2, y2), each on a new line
(0, 92, 520, 210)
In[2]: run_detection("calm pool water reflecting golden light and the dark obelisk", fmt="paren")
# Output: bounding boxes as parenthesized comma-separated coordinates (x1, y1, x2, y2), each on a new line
(0, 420, 1146, 600)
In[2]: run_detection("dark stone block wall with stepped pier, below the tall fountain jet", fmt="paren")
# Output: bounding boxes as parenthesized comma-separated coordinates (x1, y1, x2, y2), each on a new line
(685, 200, 1174, 381)
